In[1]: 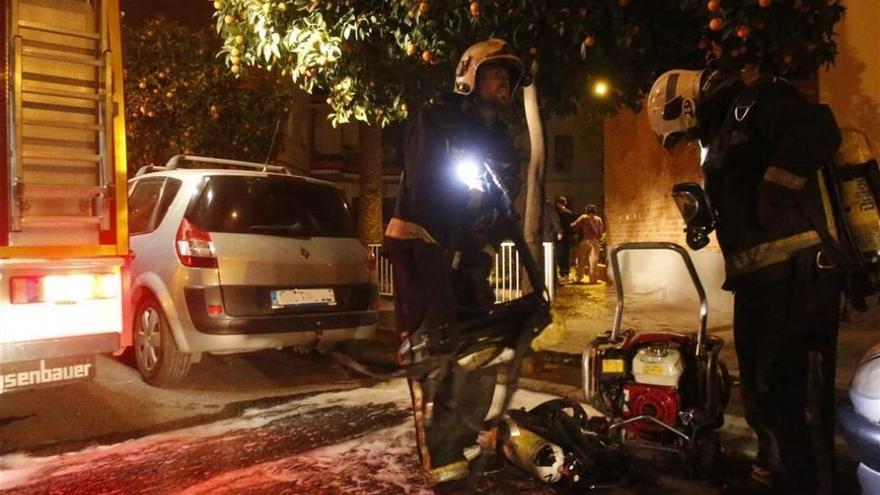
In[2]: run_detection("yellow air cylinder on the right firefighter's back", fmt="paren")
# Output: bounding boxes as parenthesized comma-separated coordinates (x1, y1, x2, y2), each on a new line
(834, 129, 880, 263)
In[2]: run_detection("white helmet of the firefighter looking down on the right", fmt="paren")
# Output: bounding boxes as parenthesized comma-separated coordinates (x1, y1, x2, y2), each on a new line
(648, 70, 703, 146)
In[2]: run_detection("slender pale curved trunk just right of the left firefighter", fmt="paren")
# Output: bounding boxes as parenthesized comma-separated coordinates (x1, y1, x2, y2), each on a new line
(523, 63, 546, 292)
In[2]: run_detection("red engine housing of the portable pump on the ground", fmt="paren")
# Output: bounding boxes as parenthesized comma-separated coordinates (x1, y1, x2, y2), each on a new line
(623, 383, 681, 436)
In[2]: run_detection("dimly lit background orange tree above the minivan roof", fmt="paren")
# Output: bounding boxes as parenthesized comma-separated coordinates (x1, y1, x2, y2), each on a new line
(123, 18, 290, 171)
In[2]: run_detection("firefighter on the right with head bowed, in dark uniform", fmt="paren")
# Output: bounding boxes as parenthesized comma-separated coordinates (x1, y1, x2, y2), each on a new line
(648, 68, 843, 494)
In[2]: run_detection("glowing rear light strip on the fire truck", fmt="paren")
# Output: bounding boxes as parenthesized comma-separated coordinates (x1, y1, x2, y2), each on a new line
(9, 273, 122, 304)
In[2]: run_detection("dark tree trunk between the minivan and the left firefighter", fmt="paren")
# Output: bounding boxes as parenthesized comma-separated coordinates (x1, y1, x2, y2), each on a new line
(358, 123, 383, 244)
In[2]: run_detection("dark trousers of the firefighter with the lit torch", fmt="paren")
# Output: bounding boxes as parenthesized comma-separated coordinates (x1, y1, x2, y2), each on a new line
(384, 238, 496, 483)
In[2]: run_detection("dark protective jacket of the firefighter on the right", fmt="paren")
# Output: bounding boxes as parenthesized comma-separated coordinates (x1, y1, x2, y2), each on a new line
(703, 78, 840, 290)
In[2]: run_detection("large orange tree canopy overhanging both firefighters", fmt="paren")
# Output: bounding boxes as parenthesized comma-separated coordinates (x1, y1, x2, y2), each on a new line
(214, 0, 843, 125)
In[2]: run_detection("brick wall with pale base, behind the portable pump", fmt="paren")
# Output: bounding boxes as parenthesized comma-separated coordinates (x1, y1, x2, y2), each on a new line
(603, 110, 732, 314)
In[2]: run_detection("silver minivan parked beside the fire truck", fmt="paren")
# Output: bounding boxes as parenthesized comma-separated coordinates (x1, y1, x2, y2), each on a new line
(128, 155, 377, 386)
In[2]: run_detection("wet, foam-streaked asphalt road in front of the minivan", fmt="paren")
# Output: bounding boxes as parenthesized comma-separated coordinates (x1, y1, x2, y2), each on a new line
(0, 351, 854, 495)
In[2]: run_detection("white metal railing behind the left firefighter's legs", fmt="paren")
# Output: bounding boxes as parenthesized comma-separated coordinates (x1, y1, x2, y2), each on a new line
(369, 242, 556, 302)
